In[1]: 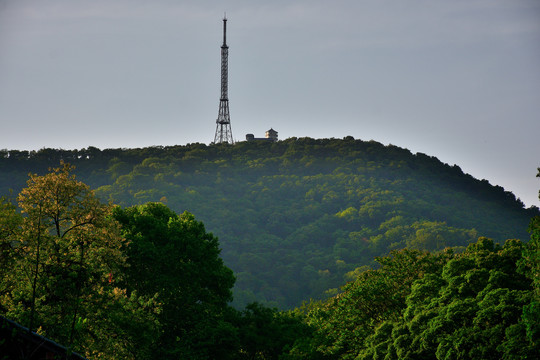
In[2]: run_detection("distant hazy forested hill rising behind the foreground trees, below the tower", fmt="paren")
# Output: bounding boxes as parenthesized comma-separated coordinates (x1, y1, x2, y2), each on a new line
(0, 137, 539, 308)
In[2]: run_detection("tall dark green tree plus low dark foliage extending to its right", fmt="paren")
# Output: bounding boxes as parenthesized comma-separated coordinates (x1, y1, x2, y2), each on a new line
(114, 203, 310, 359)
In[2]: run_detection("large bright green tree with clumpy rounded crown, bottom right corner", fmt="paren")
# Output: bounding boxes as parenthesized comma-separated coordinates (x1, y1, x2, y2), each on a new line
(380, 238, 537, 359)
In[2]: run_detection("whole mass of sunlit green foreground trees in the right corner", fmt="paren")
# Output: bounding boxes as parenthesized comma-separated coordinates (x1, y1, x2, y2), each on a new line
(282, 235, 540, 360)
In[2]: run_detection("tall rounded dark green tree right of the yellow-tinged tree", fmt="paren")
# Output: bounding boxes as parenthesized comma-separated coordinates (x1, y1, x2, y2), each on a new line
(114, 203, 237, 359)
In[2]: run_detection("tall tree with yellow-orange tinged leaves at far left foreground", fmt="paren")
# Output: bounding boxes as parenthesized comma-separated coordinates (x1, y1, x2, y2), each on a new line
(2, 164, 159, 358)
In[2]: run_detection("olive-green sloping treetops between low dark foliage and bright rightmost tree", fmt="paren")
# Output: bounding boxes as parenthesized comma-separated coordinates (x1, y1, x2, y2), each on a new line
(300, 249, 453, 358)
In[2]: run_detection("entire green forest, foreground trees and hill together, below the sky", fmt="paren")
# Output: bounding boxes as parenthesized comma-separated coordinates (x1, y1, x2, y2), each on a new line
(0, 138, 540, 360)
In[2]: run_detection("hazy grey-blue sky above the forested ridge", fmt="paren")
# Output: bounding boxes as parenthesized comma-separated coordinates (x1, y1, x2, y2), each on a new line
(0, 0, 540, 206)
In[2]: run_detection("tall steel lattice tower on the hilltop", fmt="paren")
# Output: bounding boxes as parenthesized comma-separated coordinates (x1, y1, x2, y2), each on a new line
(214, 17, 234, 144)
